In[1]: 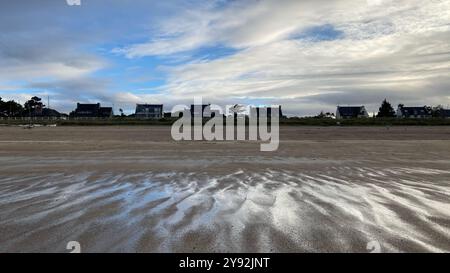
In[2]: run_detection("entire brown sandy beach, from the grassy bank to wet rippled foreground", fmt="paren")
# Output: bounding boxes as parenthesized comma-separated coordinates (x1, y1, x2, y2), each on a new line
(0, 126, 450, 252)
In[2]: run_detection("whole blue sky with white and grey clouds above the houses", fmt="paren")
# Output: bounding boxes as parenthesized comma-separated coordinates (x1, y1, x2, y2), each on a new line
(0, 0, 450, 116)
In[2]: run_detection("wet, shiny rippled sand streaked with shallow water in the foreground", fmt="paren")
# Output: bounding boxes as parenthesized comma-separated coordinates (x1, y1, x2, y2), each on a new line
(0, 166, 450, 252)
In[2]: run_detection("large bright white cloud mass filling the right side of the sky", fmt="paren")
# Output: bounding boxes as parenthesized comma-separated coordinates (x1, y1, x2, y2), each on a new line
(114, 0, 450, 112)
